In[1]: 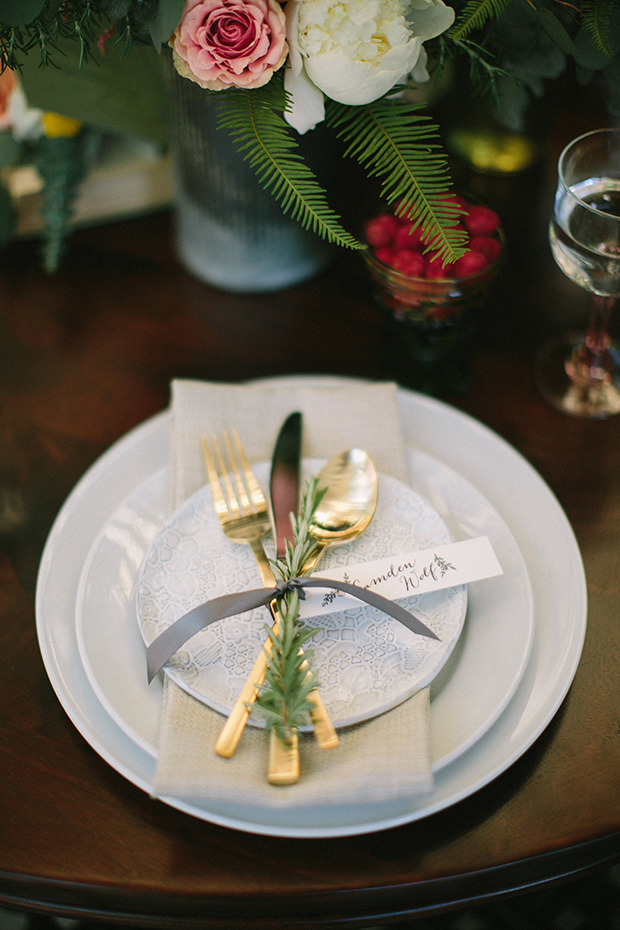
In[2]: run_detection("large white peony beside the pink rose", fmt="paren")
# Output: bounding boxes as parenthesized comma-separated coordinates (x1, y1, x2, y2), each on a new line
(286, 0, 454, 132)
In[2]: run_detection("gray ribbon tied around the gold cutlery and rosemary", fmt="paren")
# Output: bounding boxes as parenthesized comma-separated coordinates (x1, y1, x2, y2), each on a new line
(146, 577, 439, 684)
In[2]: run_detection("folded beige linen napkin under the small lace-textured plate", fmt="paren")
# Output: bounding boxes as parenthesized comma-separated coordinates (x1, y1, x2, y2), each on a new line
(152, 380, 433, 808)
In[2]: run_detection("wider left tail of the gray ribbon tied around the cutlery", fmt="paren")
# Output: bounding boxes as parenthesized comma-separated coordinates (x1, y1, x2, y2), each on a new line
(146, 588, 280, 684)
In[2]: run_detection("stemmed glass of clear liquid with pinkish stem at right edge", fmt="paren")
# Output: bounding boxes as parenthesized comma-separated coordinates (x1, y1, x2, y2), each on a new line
(536, 129, 620, 419)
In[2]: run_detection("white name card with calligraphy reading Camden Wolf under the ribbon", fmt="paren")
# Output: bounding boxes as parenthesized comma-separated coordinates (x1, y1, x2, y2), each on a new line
(300, 536, 502, 617)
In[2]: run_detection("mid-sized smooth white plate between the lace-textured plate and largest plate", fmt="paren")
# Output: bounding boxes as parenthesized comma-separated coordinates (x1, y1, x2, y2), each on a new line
(76, 449, 534, 771)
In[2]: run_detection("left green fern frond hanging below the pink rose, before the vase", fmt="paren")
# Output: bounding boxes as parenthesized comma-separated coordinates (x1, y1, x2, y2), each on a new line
(218, 78, 364, 249)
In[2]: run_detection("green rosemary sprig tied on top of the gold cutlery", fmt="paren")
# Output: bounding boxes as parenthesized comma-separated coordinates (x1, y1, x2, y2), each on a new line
(256, 478, 326, 744)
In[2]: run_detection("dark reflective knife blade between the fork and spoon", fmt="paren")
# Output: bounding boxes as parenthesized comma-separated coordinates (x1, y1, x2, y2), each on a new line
(269, 411, 302, 559)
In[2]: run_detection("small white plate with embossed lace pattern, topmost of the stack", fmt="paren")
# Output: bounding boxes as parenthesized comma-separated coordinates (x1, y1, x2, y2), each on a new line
(138, 460, 467, 727)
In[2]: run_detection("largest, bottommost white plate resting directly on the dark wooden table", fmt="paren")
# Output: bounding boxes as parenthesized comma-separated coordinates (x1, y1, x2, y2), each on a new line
(36, 378, 586, 837)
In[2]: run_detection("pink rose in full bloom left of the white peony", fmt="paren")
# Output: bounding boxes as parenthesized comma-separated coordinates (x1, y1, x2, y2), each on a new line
(170, 0, 288, 90)
